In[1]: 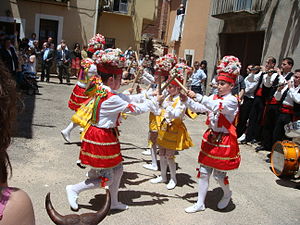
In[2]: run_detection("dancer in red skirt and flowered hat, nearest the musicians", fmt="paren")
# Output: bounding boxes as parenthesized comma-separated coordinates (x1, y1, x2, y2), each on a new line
(185, 56, 241, 213)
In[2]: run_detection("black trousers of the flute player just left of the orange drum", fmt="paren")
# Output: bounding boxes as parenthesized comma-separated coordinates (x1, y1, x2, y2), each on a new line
(261, 104, 280, 151)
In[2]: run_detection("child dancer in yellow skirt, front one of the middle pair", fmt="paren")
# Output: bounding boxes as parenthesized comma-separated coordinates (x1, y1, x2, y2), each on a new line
(150, 63, 193, 190)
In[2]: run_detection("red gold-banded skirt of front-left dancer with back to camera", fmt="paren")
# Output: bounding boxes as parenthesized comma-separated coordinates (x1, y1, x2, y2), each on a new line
(79, 126, 123, 168)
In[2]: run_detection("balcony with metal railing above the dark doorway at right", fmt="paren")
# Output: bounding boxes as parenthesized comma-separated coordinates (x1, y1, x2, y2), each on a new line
(212, 0, 263, 20)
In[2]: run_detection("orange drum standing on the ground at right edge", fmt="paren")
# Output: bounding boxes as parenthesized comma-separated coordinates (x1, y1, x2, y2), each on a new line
(271, 141, 299, 177)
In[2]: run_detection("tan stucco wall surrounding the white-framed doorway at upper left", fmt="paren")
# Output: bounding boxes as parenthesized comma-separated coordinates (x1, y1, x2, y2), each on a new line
(3, 0, 95, 46)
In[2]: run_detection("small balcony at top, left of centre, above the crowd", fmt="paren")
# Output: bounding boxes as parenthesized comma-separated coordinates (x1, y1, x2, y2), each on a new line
(102, 0, 132, 16)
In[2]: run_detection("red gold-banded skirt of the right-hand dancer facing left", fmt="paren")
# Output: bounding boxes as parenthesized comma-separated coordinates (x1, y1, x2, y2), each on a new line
(198, 130, 241, 170)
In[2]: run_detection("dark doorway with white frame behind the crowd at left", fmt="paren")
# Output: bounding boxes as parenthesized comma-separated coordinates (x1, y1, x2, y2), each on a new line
(39, 19, 58, 47)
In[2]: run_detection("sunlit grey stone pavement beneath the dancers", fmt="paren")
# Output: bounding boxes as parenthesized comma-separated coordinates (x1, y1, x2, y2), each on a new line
(9, 78, 300, 225)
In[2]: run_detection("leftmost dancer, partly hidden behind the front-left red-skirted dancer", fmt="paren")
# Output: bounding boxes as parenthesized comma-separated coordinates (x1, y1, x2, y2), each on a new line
(61, 34, 105, 143)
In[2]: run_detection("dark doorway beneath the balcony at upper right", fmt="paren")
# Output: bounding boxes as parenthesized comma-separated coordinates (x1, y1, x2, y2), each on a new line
(220, 31, 265, 75)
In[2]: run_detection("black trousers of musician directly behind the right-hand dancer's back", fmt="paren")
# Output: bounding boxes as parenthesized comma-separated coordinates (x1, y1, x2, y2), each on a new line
(236, 96, 254, 137)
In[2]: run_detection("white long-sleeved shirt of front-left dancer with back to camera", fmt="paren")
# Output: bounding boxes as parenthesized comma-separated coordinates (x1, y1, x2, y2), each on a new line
(93, 85, 152, 128)
